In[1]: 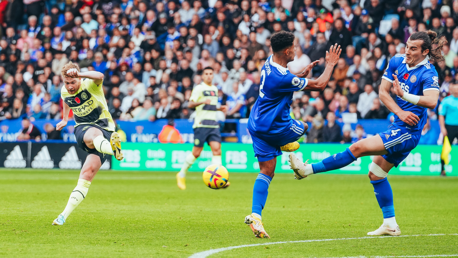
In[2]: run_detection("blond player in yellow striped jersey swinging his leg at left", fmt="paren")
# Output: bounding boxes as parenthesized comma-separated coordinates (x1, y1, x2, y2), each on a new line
(52, 62, 123, 225)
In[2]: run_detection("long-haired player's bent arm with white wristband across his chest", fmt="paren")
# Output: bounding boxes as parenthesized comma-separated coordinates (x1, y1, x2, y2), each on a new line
(393, 74, 439, 109)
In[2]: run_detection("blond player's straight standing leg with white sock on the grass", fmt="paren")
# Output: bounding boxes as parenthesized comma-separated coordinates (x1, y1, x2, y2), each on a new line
(52, 154, 102, 225)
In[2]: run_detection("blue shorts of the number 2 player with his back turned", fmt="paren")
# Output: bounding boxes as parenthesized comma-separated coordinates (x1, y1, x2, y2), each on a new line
(249, 120, 305, 162)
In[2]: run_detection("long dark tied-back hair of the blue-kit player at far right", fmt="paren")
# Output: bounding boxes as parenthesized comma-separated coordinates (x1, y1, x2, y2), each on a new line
(410, 30, 447, 62)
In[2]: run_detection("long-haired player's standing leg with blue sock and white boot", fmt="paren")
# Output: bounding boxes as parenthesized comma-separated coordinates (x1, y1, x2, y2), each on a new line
(367, 156, 401, 236)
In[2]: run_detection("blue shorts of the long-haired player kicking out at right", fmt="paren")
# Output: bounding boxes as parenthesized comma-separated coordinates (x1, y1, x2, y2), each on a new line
(379, 124, 421, 167)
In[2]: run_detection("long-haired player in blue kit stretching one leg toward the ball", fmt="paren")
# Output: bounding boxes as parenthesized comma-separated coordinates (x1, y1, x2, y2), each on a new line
(290, 31, 444, 236)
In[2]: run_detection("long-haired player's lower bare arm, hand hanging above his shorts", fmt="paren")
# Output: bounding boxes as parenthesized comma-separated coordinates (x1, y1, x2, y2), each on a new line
(379, 79, 420, 126)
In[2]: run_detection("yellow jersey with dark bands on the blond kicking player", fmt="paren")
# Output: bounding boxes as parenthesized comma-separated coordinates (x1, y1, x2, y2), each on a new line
(61, 78, 115, 132)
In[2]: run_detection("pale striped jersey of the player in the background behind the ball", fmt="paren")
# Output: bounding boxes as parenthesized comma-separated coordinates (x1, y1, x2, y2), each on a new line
(190, 82, 219, 128)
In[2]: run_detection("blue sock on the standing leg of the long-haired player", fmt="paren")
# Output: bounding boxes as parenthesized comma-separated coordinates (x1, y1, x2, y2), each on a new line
(371, 178, 394, 219)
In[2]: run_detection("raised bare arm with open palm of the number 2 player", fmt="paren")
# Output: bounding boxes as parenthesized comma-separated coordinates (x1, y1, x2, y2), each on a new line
(304, 44, 342, 91)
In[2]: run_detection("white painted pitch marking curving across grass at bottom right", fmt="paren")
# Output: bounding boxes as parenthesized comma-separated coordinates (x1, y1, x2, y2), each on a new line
(189, 234, 458, 258)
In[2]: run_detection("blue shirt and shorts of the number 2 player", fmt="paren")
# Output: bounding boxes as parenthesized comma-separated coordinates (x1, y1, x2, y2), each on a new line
(248, 56, 308, 162)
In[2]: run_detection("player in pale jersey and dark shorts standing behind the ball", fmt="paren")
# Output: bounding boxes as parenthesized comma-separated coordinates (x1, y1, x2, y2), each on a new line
(176, 67, 230, 190)
